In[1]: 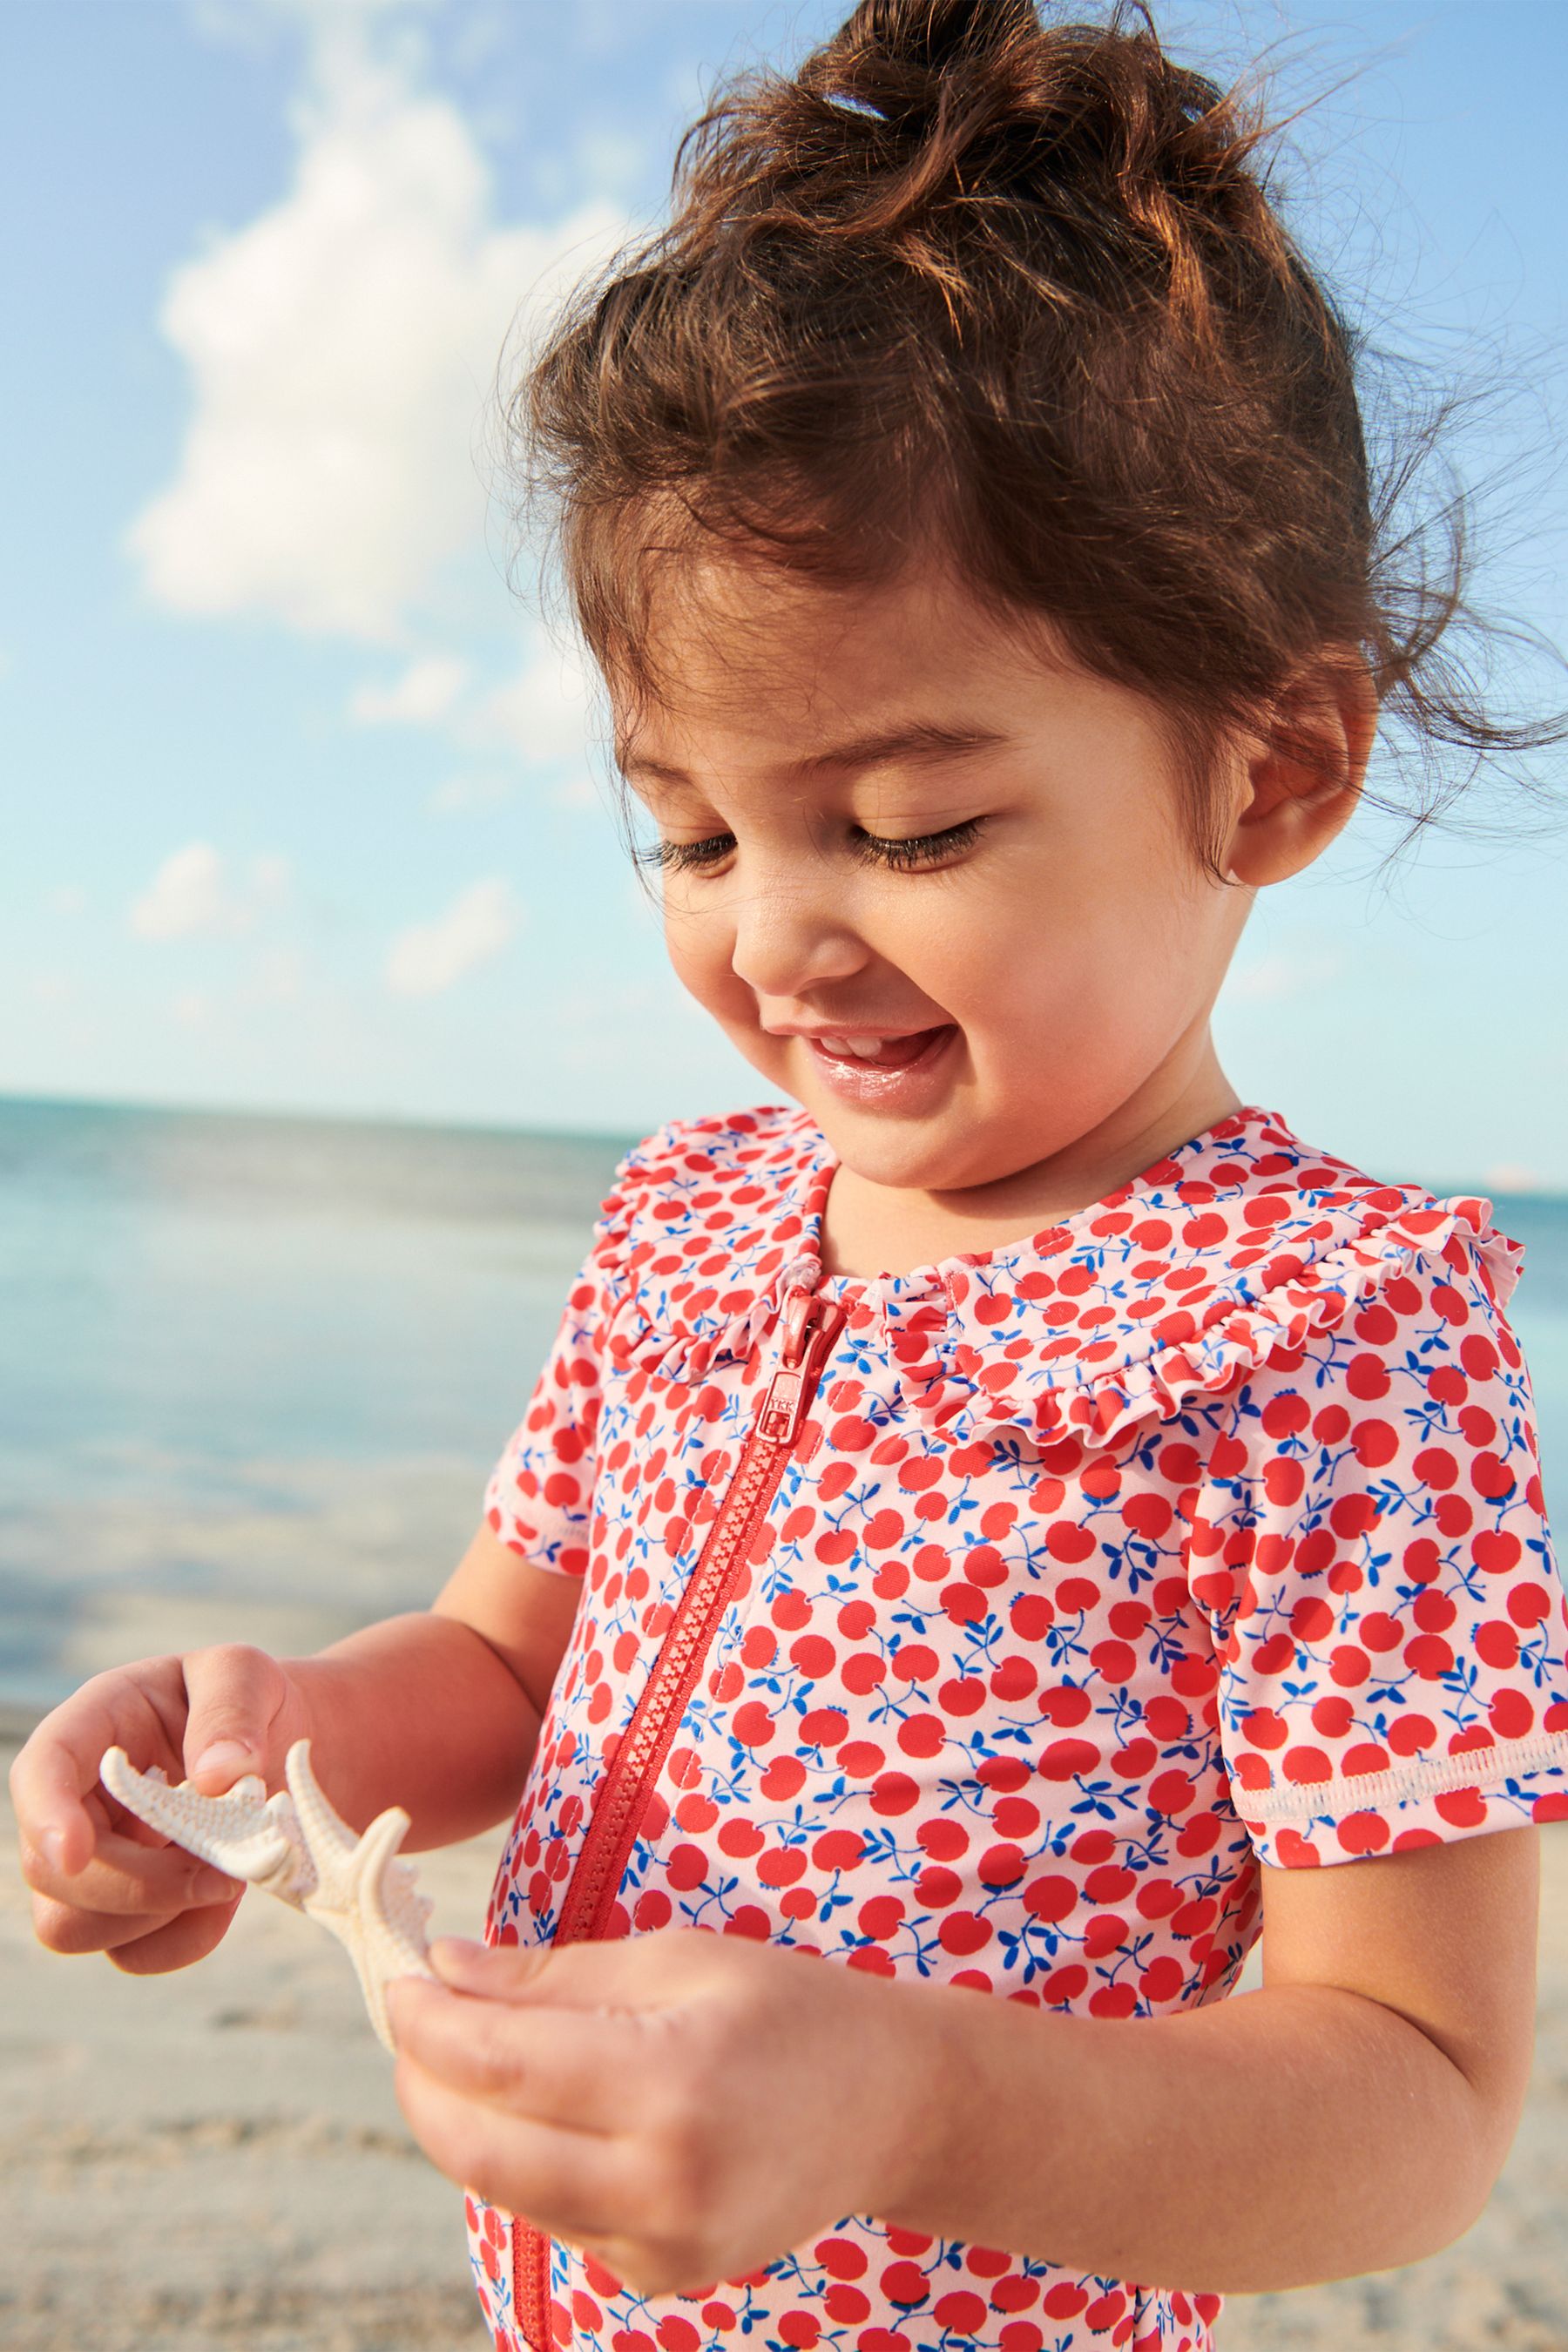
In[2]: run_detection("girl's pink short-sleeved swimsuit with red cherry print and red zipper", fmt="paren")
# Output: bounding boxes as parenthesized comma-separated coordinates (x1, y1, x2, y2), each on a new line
(468, 1105, 1568, 2352)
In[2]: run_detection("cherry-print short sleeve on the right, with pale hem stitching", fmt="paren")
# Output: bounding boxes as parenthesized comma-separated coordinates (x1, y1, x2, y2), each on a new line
(1190, 1235, 1568, 1868)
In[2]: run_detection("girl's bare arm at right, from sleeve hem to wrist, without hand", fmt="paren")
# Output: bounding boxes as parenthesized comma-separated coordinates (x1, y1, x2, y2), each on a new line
(875, 1828, 1540, 2295)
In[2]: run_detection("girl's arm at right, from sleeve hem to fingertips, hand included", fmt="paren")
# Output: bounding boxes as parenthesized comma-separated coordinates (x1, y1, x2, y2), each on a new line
(388, 1828, 1540, 2295)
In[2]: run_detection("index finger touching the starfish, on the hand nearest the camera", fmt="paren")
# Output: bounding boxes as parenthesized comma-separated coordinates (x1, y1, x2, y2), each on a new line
(388, 1976, 646, 2133)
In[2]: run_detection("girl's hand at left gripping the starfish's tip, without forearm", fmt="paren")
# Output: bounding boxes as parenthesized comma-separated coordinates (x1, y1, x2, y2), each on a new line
(11, 1644, 310, 1976)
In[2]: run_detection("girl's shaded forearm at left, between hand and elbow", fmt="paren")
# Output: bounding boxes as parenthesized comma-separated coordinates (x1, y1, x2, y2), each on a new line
(282, 1612, 538, 1851)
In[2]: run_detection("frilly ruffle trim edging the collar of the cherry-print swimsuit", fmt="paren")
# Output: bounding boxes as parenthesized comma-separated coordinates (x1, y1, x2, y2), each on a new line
(606, 1195, 1524, 1447)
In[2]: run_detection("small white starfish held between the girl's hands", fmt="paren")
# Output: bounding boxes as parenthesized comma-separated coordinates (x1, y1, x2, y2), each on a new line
(98, 1740, 435, 2051)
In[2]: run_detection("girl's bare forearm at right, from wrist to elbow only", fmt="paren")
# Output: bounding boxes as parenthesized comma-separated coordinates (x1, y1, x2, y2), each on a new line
(875, 1985, 1495, 2295)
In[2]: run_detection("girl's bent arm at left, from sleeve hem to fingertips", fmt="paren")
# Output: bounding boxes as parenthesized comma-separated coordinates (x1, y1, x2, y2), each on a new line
(11, 1526, 581, 1976)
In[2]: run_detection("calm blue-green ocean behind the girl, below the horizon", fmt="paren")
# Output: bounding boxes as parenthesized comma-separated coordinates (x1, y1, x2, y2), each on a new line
(0, 1098, 1568, 1710)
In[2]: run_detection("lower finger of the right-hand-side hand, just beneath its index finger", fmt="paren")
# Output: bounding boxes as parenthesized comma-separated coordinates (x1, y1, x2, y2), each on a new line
(393, 2051, 642, 2244)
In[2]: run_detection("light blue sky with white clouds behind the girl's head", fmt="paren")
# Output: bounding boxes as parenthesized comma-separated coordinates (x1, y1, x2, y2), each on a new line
(0, 0, 1568, 1188)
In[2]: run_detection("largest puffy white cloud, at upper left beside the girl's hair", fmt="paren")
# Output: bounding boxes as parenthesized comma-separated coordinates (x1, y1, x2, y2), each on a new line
(129, 0, 623, 642)
